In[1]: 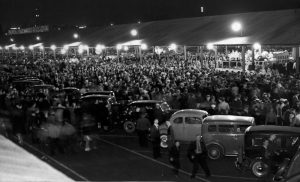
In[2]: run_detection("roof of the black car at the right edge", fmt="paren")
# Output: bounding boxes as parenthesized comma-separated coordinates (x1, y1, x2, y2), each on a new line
(246, 125, 300, 134)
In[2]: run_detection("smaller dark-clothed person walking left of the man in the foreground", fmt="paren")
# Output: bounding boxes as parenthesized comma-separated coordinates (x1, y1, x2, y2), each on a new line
(169, 141, 180, 176)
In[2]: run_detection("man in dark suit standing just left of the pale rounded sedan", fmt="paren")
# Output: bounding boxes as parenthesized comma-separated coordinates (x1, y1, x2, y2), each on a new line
(150, 119, 161, 159)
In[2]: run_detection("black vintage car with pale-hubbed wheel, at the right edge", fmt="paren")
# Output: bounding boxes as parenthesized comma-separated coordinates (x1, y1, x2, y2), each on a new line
(235, 125, 300, 178)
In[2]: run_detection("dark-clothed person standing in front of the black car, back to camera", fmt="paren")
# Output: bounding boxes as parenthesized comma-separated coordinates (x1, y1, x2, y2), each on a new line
(136, 113, 151, 147)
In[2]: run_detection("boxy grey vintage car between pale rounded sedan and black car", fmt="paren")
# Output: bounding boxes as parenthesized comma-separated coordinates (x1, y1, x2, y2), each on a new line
(201, 115, 255, 160)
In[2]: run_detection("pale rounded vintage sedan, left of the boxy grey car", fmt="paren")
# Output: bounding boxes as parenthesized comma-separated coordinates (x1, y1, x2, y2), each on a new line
(170, 109, 208, 141)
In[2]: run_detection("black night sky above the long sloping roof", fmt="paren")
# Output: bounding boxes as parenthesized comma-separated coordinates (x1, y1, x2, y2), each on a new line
(0, 0, 300, 30)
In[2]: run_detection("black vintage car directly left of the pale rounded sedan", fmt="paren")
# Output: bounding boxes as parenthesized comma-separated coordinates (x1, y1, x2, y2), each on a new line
(121, 100, 173, 133)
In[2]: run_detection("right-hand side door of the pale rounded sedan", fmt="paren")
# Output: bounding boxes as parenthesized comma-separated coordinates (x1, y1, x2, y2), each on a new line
(184, 116, 202, 141)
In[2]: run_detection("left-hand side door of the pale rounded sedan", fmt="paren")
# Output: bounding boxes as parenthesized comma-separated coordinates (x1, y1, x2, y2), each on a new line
(171, 116, 184, 140)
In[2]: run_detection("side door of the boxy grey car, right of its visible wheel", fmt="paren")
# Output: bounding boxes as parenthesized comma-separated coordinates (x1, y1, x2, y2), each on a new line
(218, 123, 238, 155)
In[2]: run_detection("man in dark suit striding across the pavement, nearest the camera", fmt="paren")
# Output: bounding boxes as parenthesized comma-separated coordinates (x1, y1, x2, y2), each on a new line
(187, 135, 211, 178)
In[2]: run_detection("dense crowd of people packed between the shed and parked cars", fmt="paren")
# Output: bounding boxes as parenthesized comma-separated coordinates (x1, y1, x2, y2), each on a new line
(0, 54, 300, 153)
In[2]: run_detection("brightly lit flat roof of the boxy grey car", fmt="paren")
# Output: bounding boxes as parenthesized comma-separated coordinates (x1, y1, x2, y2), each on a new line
(203, 115, 254, 123)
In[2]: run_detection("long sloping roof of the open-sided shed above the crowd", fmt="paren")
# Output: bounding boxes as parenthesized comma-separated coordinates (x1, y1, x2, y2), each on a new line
(0, 9, 300, 47)
